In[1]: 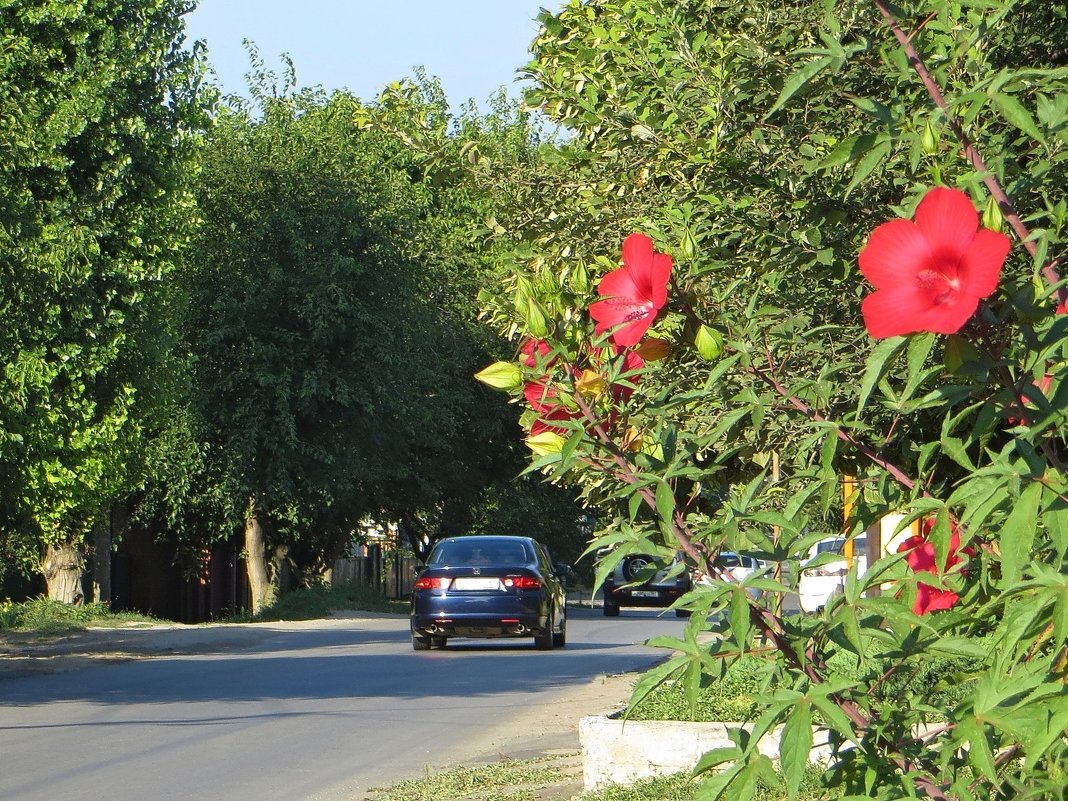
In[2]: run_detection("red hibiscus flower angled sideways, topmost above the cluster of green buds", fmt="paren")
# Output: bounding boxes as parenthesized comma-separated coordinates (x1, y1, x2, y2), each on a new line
(590, 234, 671, 347)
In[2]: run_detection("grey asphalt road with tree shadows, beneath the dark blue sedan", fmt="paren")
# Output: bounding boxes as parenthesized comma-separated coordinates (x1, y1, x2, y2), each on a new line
(0, 609, 681, 801)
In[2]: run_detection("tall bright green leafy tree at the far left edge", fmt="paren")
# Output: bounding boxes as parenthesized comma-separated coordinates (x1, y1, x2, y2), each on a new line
(0, 0, 210, 601)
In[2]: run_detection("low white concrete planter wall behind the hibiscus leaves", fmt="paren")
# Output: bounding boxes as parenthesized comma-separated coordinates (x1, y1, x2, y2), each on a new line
(579, 716, 829, 790)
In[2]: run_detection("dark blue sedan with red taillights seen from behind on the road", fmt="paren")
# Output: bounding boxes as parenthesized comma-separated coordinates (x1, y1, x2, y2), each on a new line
(411, 536, 570, 650)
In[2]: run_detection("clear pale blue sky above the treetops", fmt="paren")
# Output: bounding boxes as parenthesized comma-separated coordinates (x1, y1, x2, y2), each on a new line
(186, 0, 564, 111)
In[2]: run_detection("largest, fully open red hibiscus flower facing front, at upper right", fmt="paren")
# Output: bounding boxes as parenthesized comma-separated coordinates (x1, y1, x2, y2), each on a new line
(858, 187, 1010, 340)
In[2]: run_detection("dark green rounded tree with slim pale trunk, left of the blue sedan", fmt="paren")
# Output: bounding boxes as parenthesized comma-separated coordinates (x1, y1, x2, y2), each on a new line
(183, 67, 422, 610)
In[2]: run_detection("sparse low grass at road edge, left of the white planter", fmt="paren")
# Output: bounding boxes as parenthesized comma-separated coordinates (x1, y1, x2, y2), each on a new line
(371, 757, 570, 801)
